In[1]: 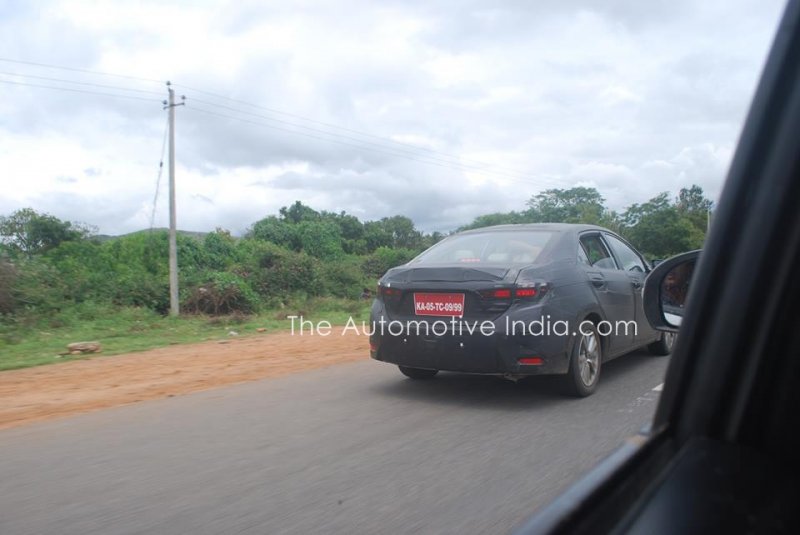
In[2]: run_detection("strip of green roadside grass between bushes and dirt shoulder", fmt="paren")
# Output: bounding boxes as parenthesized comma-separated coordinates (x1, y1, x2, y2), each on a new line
(0, 298, 370, 371)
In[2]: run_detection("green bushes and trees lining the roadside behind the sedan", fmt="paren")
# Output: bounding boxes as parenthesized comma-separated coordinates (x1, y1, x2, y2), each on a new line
(0, 191, 712, 328)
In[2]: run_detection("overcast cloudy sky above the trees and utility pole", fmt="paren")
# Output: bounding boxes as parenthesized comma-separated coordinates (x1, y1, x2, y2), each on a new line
(0, 0, 784, 234)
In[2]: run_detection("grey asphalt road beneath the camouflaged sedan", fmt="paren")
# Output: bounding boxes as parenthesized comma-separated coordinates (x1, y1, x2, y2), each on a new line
(0, 353, 668, 535)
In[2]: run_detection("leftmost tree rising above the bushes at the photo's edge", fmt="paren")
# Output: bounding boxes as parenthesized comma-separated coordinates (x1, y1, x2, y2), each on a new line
(0, 208, 91, 256)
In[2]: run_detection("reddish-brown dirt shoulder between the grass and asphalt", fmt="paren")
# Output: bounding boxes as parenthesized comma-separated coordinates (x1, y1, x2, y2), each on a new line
(0, 331, 369, 429)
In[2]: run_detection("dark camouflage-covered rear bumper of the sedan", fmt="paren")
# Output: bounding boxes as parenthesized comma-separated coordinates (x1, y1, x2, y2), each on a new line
(370, 306, 572, 375)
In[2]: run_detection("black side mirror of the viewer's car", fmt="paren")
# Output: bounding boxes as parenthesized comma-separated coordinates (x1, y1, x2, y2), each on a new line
(642, 251, 700, 333)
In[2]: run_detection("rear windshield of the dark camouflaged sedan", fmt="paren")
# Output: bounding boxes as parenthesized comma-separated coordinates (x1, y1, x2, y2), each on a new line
(412, 230, 554, 264)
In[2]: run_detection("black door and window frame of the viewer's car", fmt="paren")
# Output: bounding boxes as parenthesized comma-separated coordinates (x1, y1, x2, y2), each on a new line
(519, 0, 800, 535)
